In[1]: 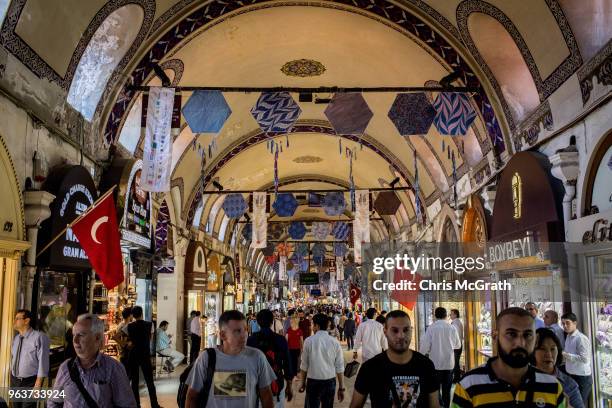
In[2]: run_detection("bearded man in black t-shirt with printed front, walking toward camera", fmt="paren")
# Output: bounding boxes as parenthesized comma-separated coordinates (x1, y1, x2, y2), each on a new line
(350, 310, 440, 408)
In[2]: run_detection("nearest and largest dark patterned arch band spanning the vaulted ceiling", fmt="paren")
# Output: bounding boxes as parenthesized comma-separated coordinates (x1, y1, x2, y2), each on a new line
(104, 0, 505, 153)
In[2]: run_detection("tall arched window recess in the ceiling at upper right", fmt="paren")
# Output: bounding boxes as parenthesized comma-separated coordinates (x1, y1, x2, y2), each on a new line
(468, 13, 540, 122)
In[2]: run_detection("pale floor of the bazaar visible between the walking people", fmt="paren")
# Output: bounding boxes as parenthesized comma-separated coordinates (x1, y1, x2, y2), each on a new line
(140, 345, 355, 408)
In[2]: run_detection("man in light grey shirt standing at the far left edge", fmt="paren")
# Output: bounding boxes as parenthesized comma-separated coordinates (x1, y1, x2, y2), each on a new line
(11, 309, 49, 408)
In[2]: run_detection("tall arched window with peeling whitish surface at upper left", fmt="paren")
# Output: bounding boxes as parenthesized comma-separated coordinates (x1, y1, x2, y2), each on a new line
(68, 4, 144, 121)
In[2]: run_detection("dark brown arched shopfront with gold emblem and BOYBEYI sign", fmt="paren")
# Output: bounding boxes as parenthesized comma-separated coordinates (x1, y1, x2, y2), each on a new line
(486, 152, 567, 334)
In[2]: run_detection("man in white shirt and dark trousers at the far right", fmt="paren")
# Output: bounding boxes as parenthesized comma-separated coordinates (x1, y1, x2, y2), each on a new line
(561, 313, 593, 407)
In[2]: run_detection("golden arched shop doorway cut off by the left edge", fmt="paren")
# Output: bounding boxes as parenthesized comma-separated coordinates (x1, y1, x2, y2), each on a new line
(0, 138, 30, 389)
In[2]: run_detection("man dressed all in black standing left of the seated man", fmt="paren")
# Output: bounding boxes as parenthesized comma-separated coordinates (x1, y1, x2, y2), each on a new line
(128, 306, 160, 408)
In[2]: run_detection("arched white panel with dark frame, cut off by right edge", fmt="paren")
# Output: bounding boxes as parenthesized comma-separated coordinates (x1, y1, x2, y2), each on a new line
(582, 131, 612, 215)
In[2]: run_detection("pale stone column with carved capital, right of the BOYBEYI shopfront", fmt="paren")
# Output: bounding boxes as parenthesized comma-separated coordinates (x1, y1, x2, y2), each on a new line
(548, 146, 580, 241)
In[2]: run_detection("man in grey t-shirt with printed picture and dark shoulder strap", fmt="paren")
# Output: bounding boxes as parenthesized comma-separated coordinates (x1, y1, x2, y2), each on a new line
(179, 310, 275, 408)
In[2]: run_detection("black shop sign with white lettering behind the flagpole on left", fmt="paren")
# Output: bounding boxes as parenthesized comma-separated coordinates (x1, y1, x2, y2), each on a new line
(38, 166, 97, 269)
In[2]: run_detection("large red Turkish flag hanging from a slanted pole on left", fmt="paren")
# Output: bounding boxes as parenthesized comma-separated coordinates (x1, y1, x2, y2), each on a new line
(71, 194, 123, 289)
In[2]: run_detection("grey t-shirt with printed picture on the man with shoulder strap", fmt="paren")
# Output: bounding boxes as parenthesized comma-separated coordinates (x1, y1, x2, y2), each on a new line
(187, 346, 276, 408)
